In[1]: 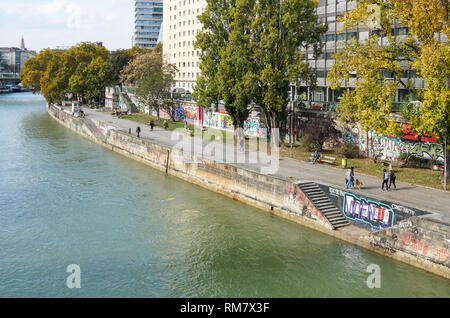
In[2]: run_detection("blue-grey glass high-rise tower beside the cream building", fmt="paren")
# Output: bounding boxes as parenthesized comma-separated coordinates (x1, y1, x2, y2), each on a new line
(133, 0, 163, 49)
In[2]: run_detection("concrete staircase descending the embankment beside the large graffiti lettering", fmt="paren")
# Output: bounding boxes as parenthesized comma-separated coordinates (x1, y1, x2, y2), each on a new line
(297, 182, 350, 230)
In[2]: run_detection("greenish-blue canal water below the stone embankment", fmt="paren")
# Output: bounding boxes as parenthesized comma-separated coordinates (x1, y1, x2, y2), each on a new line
(0, 93, 450, 297)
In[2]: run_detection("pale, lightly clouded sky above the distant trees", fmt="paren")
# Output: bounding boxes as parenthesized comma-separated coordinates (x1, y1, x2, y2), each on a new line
(0, 0, 134, 51)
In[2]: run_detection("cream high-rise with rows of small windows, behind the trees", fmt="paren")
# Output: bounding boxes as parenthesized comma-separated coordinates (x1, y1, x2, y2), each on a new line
(163, 0, 206, 92)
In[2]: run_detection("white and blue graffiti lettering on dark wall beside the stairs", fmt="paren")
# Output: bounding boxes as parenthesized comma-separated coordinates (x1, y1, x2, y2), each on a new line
(342, 193, 395, 230)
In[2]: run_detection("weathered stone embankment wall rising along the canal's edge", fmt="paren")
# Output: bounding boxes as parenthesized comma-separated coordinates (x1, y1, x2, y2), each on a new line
(47, 105, 450, 279)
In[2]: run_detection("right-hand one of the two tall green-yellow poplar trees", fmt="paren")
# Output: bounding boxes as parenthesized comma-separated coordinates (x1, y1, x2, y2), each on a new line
(248, 0, 327, 141)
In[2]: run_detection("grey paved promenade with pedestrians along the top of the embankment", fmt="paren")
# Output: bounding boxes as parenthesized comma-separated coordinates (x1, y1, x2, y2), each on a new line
(85, 109, 450, 224)
